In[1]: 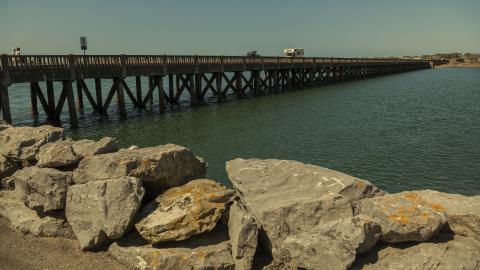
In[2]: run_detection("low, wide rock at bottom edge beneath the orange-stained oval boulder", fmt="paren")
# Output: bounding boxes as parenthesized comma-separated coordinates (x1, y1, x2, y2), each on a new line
(108, 229, 234, 270)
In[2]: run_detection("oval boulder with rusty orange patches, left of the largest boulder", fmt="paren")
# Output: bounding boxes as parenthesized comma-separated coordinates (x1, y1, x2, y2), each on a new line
(135, 179, 233, 244)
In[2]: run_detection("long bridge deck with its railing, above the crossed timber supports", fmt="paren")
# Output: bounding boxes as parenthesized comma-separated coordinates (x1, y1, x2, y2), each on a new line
(0, 55, 428, 83)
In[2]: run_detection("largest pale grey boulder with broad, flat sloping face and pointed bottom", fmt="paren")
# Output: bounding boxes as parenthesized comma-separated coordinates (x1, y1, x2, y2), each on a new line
(226, 159, 383, 259)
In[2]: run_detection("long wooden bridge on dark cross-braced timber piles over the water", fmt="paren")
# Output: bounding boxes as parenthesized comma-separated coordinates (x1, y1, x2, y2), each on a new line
(0, 55, 433, 126)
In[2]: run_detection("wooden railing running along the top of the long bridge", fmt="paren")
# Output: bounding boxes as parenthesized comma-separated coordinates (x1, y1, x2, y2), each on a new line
(0, 55, 426, 73)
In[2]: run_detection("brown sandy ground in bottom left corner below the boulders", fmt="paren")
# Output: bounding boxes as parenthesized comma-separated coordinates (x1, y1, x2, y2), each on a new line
(0, 218, 126, 270)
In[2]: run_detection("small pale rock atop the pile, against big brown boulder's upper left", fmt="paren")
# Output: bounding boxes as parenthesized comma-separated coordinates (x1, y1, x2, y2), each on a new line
(73, 137, 118, 159)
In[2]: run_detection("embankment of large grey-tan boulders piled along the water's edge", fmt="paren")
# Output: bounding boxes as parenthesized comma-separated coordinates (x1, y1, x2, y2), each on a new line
(0, 123, 480, 270)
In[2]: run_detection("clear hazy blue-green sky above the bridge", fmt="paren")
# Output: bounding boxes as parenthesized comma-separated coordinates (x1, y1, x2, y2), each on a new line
(0, 0, 480, 56)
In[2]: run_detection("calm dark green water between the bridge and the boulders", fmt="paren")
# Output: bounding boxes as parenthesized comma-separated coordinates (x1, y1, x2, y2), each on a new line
(10, 68, 480, 194)
